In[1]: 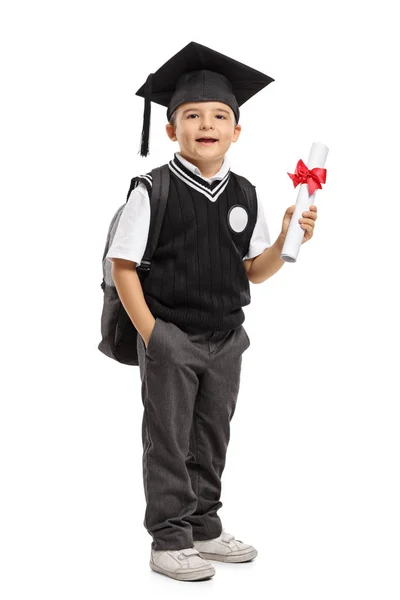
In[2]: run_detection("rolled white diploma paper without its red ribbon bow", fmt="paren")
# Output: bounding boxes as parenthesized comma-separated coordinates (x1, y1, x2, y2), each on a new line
(281, 142, 329, 262)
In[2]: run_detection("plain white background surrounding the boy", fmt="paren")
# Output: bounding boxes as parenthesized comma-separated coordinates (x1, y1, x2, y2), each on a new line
(0, 0, 400, 600)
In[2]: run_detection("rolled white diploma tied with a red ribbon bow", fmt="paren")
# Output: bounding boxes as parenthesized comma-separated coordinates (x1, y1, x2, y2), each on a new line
(281, 142, 329, 262)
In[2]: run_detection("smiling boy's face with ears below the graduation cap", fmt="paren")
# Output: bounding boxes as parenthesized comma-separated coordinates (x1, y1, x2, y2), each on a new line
(166, 102, 241, 165)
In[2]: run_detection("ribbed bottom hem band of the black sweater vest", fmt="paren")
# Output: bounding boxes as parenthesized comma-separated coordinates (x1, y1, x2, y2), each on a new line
(145, 294, 245, 331)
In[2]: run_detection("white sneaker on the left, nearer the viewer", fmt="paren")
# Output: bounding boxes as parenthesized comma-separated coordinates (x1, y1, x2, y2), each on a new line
(150, 548, 215, 581)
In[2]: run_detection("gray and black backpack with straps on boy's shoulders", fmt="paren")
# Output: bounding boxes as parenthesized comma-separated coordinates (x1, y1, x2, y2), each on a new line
(98, 164, 257, 366)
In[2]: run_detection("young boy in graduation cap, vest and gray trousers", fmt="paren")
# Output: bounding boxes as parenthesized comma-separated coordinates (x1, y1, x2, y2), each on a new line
(107, 42, 316, 580)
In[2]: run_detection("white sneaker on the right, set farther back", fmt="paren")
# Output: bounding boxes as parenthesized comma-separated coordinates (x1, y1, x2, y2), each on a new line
(193, 531, 258, 562)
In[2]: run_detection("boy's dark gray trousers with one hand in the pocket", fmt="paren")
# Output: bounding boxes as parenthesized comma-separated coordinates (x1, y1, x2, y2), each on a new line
(137, 317, 250, 550)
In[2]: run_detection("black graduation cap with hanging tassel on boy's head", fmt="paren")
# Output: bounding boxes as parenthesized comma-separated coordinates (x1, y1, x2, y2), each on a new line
(136, 42, 275, 156)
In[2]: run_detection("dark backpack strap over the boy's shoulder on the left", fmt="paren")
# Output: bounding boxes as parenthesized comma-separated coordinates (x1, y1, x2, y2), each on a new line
(137, 164, 170, 271)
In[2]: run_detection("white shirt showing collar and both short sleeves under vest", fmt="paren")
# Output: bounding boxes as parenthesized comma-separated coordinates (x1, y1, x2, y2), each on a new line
(106, 152, 271, 264)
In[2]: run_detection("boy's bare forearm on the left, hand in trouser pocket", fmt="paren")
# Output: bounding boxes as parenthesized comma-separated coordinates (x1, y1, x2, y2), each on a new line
(111, 258, 155, 347)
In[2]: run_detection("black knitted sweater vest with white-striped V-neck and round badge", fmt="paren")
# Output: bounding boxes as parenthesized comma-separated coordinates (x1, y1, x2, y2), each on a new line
(141, 157, 257, 331)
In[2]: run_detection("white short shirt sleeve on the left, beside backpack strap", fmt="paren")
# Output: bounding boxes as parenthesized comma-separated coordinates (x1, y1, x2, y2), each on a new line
(106, 183, 150, 264)
